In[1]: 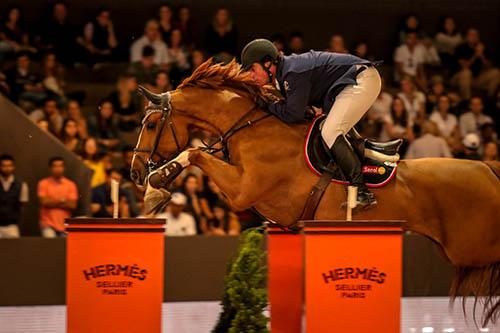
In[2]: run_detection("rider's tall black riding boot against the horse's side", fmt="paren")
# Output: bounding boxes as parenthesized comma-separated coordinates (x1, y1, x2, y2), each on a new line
(330, 135, 377, 208)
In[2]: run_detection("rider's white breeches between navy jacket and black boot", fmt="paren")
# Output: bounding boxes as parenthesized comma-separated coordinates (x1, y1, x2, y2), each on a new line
(321, 65, 381, 148)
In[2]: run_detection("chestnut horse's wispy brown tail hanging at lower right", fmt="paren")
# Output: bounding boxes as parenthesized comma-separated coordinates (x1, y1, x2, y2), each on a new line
(450, 261, 500, 327)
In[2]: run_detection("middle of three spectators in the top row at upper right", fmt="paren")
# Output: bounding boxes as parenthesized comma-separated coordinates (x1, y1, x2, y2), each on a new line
(434, 16, 462, 67)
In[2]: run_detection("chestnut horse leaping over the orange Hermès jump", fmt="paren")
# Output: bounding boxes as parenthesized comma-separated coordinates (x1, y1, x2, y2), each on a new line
(131, 61, 500, 323)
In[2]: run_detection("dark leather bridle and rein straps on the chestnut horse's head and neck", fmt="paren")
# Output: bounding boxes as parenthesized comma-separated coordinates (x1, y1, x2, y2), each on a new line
(134, 92, 271, 172)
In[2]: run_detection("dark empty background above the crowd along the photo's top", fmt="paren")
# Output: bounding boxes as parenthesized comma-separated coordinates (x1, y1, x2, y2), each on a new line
(0, 0, 500, 61)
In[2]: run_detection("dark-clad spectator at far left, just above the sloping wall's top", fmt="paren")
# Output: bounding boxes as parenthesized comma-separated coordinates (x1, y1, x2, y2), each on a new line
(6, 52, 47, 104)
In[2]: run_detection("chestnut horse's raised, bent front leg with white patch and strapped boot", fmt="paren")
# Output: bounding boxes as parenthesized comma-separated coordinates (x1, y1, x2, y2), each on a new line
(148, 149, 252, 210)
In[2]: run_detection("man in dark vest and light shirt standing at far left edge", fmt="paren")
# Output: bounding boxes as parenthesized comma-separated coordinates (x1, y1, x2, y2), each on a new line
(0, 154, 29, 238)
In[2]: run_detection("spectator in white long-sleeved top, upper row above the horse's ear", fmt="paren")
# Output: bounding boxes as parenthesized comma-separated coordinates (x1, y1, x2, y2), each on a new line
(130, 20, 170, 67)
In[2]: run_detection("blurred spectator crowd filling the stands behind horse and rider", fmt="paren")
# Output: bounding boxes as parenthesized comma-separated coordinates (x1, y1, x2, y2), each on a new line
(0, 2, 500, 237)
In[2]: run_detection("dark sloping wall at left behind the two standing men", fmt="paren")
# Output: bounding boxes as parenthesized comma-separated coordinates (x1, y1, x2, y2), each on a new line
(0, 94, 91, 236)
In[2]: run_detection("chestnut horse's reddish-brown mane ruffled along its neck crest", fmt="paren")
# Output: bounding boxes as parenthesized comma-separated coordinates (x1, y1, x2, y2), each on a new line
(177, 58, 268, 98)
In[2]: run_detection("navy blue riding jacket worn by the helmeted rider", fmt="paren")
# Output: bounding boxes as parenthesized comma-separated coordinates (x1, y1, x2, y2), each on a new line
(268, 51, 374, 123)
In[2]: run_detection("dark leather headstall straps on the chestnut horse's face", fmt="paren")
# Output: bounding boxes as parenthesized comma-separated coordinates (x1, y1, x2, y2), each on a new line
(134, 92, 182, 172)
